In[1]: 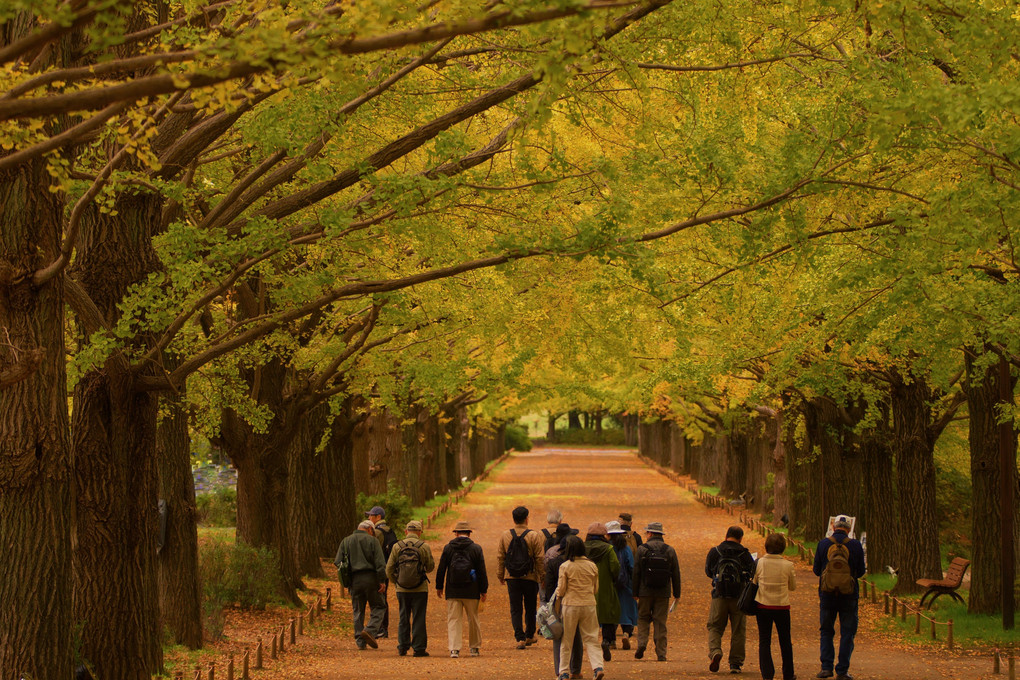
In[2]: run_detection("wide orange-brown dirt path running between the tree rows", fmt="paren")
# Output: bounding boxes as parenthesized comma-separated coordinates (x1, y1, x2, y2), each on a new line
(286, 449, 990, 680)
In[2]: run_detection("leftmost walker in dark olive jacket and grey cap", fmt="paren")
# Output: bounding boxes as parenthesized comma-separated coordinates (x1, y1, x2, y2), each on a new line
(334, 520, 386, 649)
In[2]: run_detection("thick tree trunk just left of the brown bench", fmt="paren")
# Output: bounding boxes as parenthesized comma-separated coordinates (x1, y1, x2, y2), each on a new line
(890, 375, 942, 592)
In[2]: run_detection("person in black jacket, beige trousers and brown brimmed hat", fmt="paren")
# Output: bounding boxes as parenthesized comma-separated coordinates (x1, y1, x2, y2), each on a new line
(436, 521, 489, 659)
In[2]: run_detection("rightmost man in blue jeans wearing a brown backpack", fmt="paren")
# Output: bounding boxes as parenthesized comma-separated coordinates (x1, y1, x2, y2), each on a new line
(814, 515, 864, 680)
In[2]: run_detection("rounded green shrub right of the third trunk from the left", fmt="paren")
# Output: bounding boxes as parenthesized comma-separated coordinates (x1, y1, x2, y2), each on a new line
(199, 540, 282, 640)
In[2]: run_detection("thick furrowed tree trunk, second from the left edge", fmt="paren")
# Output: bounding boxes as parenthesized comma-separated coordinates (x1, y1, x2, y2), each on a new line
(71, 194, 162, 680)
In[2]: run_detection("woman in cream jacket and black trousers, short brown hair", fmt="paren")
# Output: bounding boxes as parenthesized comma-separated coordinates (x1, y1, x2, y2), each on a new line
(753, 533, 797, 680)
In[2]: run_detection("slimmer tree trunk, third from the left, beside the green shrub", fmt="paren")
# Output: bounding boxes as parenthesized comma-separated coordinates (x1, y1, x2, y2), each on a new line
(156, 391, 202, 649)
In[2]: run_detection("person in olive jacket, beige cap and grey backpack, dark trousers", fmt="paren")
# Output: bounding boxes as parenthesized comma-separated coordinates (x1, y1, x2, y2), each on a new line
(386, 520, 436, 657)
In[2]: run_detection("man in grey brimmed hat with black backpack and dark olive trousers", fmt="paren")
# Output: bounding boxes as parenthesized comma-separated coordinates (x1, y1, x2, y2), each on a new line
(633, 522, 680, 661)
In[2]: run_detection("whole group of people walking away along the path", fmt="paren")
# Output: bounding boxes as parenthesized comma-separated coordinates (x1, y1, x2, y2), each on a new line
(336, 506, 864, 680)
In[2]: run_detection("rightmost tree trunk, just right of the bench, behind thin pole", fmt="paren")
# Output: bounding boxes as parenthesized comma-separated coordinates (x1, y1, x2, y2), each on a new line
(964, 352, 1020, 614)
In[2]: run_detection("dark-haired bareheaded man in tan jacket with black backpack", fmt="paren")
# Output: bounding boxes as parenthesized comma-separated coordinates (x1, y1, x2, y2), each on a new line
(496, 506, 546, 649)
